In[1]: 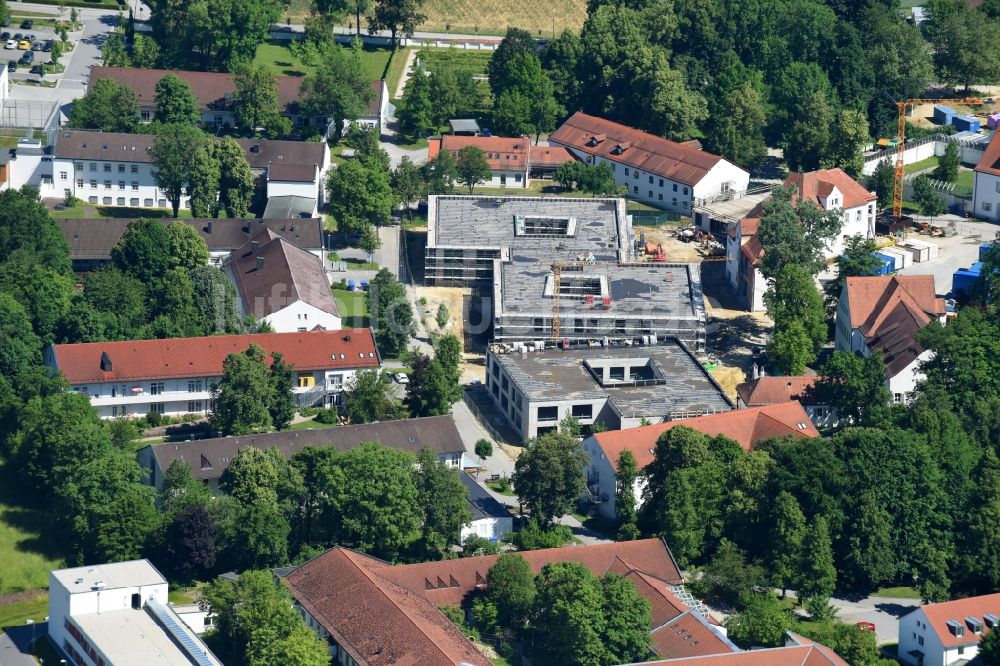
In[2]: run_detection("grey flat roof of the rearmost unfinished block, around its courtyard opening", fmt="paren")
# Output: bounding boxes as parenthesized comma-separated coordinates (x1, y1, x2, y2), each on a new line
(427, 196, 631, 262)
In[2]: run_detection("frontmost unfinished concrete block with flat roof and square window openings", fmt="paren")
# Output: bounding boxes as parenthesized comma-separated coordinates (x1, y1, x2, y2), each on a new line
(486, 339, 733, 440)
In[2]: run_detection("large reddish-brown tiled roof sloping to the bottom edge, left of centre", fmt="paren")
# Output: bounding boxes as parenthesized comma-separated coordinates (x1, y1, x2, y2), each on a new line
(284, 548, 491, 666)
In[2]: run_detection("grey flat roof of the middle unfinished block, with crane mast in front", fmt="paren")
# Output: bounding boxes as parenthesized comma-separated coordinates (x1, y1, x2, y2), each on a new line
(498, 257, 704, 320)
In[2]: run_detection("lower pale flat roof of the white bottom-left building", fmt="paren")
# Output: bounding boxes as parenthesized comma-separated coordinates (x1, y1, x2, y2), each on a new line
(73, 608, 220, 666)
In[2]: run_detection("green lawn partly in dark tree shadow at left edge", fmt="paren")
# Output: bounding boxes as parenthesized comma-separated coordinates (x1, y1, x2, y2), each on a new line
(0, 465, 63, 594)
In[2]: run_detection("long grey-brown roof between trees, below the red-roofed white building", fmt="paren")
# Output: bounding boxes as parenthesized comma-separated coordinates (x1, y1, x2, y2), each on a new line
(151, 415, 465, 481)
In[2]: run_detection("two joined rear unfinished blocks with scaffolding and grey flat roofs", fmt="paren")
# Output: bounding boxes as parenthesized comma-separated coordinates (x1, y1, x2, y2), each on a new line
(425, 196, 705, 351)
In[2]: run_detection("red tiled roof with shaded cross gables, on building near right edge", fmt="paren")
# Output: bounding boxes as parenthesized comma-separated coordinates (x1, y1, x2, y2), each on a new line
(846, 275, 945, 377)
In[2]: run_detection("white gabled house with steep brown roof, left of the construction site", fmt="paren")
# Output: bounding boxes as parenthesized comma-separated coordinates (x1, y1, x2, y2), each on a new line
(224, 229, 341, 333)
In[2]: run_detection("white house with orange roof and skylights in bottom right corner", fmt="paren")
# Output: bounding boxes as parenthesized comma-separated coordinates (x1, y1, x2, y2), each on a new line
(897, 594, 1000, 666)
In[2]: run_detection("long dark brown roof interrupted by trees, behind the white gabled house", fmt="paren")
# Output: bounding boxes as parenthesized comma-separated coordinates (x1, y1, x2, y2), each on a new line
(55, 217, 323, 261)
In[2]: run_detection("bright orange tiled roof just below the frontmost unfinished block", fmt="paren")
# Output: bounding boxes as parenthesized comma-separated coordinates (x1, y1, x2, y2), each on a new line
(594, 401, 819, 469)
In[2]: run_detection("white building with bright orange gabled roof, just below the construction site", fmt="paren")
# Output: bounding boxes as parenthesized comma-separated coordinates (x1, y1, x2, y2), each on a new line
(581, 401, 819, 520)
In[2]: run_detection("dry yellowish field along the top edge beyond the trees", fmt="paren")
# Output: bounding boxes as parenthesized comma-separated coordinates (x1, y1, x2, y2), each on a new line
(285, 0, 587, 37)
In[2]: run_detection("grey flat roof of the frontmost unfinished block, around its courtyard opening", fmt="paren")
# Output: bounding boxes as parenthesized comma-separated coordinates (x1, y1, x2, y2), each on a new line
(495, 340, 733, 418)
